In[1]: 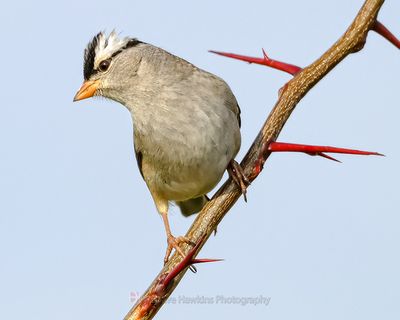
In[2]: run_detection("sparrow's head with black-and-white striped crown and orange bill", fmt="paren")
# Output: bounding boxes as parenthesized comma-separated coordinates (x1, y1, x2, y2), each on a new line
(74, 31, 143, 101)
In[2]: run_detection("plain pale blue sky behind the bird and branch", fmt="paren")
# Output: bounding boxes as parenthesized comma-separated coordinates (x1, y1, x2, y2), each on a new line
(0, 0, 400, 320)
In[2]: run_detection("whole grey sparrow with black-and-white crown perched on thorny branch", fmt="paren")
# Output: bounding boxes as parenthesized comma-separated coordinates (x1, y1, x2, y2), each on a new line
(74, 31, 249, 263)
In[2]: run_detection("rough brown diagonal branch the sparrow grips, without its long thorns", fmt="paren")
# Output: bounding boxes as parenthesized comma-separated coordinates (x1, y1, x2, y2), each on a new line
(125, 0, 384, 320)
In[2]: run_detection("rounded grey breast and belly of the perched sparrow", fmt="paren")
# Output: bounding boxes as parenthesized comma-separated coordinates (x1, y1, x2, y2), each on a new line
(131, 47, 240, 200)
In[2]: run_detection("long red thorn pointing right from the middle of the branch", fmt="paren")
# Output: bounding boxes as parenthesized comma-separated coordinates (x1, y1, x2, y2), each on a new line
(268, 142, 383, 162)
